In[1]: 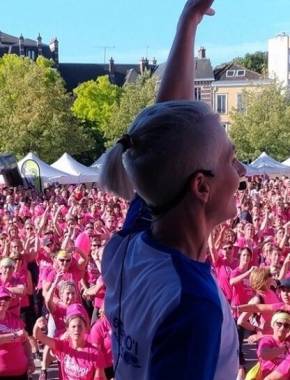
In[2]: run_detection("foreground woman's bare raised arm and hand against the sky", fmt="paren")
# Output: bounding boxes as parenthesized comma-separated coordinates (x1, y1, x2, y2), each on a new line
(157, 0, 214, 103)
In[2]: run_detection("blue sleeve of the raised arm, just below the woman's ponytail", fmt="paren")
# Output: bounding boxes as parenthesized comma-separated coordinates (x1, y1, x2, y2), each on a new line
(122, 195, 151, 233)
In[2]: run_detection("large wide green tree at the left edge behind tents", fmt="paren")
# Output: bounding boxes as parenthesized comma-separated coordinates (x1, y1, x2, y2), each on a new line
(0, 54, 91, 162)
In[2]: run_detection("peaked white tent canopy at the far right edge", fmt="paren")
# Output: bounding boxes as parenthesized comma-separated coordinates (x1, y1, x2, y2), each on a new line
(249, 152, 290, 176)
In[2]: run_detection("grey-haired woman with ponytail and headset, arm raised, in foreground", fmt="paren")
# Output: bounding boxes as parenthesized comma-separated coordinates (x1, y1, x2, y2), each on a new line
(101, 0, 244, 380)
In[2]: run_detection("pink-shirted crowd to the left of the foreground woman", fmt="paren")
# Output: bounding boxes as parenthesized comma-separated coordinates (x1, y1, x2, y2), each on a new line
(0, 185, 127, 380)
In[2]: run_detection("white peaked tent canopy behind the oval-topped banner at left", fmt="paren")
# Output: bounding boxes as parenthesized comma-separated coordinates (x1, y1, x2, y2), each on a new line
(17, 153, 77, 185)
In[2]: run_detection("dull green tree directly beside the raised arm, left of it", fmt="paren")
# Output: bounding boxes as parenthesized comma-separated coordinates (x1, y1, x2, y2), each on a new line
(105, 72, 156, 146)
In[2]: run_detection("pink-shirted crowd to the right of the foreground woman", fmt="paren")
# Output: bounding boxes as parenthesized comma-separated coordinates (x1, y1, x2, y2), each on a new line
(209, 178, 290, 379)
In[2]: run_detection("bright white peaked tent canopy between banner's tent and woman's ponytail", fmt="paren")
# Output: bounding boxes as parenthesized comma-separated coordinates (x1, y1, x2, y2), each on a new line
(51, 153, 99, 183)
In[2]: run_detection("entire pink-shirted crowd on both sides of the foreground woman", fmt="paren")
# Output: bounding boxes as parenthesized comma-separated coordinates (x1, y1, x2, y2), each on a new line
(0, 177, 290, 380)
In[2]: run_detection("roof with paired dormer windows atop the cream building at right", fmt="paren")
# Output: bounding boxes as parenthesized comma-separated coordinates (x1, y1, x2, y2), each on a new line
(214, 63, 264, 82)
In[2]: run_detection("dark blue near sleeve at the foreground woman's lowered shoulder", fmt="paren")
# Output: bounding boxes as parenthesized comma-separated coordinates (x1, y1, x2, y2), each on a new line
(149, 298, 223, 380)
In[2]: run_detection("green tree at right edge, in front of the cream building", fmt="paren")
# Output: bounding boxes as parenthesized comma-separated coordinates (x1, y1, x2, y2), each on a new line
(230, 83, 290, 161)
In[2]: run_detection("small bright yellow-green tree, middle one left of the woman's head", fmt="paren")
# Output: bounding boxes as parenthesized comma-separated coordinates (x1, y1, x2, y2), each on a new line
(72, 75, 122, 145)
